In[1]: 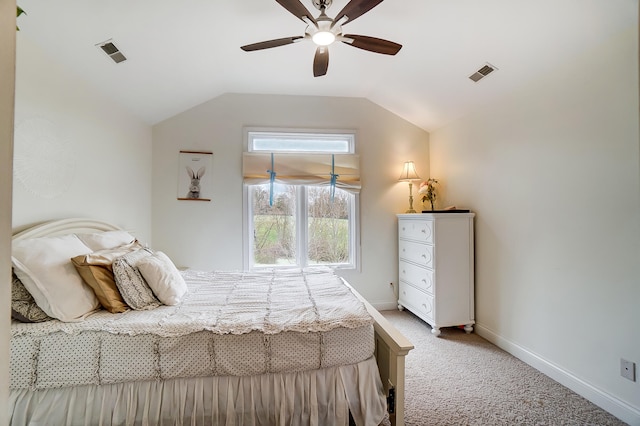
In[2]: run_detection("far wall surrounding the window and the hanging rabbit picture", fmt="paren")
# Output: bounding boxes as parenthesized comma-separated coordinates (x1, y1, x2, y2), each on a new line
(153, 94, 429, 308)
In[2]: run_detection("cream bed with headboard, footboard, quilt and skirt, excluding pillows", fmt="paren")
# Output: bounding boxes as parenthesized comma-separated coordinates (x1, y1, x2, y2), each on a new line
(9, 219, 413, 425)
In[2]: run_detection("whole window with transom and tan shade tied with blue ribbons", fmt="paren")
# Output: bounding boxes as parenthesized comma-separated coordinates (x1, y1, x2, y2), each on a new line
(243, 132, 360, 268)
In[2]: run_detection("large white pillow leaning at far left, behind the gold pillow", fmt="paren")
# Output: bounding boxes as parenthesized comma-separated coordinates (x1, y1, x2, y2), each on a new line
(11, 234, 100, 322)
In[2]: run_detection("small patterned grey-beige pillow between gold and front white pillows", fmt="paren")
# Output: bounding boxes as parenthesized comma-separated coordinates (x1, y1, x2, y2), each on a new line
(111, 249, 160, 310)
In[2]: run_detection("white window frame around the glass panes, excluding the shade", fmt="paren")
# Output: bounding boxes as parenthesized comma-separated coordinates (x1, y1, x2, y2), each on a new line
(242, 128, 361, 270)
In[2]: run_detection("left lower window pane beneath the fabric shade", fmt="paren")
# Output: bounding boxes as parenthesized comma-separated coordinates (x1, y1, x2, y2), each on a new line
(251, 184, 296, 266)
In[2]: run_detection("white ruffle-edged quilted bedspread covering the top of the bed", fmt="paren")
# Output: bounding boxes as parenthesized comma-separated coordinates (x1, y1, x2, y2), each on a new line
(11, 267, 373, 337)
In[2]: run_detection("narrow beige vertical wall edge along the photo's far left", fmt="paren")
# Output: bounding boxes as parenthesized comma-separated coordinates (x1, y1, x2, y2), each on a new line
(0, 0, 16, 425)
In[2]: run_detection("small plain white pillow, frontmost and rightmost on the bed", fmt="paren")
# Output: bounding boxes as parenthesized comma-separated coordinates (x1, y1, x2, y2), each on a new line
(138, 251, 187, 305)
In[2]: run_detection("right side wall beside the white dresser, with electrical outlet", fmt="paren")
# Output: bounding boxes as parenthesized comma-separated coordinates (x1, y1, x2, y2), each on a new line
(430, 22, 640, 424)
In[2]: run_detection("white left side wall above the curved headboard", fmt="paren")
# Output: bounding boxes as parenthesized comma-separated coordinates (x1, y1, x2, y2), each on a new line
(13, 34, 151, 241)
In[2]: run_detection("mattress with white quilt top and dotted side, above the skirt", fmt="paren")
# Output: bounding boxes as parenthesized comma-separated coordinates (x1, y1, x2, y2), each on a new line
(10, 268, 375, 390)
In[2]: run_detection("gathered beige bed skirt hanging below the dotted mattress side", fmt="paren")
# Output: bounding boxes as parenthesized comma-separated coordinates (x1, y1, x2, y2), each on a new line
(9, 358, 386, 426)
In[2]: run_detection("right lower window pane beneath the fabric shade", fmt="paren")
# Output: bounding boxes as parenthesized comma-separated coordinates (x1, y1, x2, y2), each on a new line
(307, 186, 353, 265)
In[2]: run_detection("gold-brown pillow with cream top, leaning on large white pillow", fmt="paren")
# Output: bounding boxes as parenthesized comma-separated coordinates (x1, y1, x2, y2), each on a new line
(71, 241, 142, 314)
